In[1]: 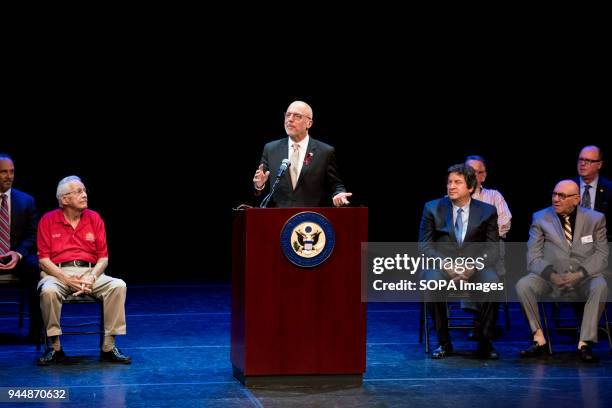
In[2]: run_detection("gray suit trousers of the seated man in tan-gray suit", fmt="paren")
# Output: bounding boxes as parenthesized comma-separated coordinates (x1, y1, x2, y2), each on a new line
(516, 273, 608, 342)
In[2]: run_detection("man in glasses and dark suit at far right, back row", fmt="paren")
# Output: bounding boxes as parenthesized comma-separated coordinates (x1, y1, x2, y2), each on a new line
(574, 146, 612, 241)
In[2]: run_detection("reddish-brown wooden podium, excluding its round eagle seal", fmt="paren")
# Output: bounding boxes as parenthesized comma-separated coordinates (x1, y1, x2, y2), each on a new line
(230, 207, 368, 386)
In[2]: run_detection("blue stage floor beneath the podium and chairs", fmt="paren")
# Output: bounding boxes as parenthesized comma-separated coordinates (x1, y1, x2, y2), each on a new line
(0, 285, 612, 408)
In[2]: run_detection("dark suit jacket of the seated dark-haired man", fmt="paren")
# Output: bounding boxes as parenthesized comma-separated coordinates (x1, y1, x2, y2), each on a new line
(419, 197, 499, 268)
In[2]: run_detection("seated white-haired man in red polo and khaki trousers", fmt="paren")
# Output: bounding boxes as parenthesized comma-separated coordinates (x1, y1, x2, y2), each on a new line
(38, 176, 131, 365)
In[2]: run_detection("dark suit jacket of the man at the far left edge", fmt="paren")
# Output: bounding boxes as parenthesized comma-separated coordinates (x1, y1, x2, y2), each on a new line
(11, 188, 38, 258)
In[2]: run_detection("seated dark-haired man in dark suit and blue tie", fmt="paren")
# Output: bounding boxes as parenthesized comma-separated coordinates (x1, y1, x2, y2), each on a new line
(419, 164, 499, 359)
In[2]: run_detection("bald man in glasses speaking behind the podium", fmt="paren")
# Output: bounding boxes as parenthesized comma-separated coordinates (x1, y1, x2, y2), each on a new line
(253, 101, 352, 207)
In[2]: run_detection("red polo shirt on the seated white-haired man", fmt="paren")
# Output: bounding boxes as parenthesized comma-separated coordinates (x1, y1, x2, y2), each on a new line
(37, 208, 108, 263)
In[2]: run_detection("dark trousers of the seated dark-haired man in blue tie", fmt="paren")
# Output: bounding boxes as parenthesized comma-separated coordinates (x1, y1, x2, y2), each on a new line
(423, 269, 499, 344)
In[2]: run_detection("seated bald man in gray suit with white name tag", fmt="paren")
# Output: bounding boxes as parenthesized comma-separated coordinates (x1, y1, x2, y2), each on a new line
(516, 180, 608, 362)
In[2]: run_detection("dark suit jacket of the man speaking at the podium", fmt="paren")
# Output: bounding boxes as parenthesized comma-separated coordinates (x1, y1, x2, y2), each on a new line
(256, 137, 346, 207)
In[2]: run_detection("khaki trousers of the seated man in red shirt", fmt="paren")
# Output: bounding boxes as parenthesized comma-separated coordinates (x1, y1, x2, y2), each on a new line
(38, 267, 127, 336)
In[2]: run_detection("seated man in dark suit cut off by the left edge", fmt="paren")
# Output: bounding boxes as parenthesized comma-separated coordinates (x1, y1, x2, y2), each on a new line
(0, 153, 41, 341)
